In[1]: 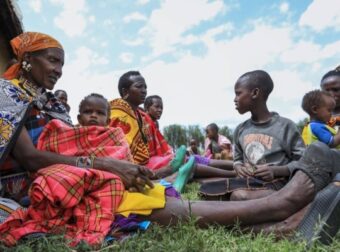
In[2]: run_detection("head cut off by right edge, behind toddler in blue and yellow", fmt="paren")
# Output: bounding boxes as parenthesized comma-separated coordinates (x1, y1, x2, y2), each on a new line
(320, 66, 340, 109)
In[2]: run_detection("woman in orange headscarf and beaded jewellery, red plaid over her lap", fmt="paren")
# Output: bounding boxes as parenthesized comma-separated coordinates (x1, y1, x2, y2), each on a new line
(0, 32, 157, 244)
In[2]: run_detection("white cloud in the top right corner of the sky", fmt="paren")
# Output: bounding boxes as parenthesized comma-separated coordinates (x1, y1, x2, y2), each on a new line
(299, 0, 340, 32)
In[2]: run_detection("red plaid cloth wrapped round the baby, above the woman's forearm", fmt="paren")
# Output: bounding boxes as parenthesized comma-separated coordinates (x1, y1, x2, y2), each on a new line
(37, 120, 132, 161)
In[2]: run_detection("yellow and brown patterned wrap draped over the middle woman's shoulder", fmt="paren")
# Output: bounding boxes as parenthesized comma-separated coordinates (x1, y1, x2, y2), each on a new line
(110, 98, 150, 165)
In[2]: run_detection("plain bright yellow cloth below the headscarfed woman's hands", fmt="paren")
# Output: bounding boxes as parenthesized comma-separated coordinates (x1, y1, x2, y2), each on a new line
(117, 184, 165, 217)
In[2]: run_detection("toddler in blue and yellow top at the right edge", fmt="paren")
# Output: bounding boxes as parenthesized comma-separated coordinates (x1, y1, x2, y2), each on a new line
(302, 90, 340, 148)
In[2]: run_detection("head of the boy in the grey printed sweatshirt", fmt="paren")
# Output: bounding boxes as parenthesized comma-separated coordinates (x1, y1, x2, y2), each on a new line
(234, 70, 274, 114)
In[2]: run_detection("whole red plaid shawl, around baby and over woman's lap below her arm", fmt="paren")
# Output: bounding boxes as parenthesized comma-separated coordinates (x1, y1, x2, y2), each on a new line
(0, 120, 130, 245)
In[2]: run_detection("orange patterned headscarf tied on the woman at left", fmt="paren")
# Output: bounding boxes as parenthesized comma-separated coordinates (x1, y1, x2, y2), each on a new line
(3, 32, 63, 80)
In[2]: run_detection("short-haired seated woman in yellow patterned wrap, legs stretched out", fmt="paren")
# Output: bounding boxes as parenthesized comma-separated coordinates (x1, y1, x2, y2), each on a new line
(110, 71, 235, 191)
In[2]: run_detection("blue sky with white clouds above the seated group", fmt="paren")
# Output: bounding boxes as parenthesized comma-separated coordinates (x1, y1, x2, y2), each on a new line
(17, 0, 340, 128)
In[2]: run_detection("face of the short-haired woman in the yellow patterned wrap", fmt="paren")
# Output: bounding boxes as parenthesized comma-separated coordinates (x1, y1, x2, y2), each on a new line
(126, 75, 147, 107)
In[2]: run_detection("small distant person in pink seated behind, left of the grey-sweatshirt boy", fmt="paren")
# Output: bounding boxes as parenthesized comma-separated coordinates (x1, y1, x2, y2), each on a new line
(204, 123, 233, 160)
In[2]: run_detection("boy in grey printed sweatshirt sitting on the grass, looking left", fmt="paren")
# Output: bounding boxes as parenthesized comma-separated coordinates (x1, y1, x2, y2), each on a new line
(230, 70, 304, 200)
